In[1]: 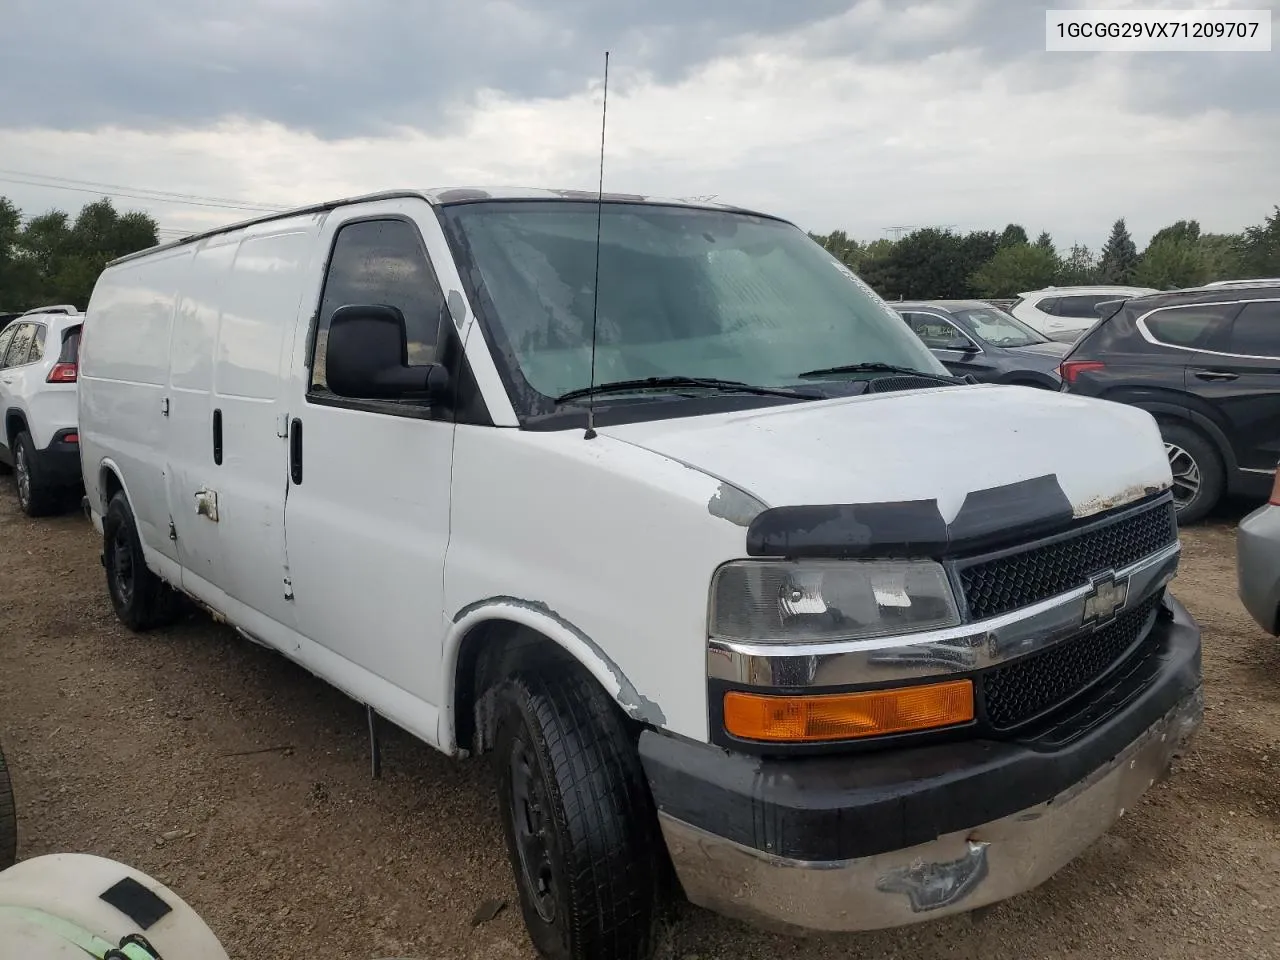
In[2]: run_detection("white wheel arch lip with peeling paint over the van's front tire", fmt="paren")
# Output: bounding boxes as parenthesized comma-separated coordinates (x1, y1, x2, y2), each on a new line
(438, 596, 667, 750)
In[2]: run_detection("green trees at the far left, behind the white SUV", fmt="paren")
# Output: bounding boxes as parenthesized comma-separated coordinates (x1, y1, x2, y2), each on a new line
(0, 197, 159, 311)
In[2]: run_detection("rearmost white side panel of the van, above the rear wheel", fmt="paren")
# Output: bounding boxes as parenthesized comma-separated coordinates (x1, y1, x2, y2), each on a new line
(78, 247, 192, 559)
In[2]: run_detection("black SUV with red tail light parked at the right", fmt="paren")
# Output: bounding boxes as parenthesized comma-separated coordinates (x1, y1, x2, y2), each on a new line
(1061, 283, 1280, 524)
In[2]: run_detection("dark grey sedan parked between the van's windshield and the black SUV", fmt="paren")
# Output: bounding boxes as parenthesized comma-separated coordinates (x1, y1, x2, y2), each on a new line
(893, 300, 1070, 390)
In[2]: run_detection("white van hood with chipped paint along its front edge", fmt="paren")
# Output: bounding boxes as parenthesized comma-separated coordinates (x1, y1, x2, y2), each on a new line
(599, 385, 1171, 522)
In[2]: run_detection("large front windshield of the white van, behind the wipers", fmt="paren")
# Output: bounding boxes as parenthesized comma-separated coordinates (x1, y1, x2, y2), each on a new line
(442, 200, 947, 413)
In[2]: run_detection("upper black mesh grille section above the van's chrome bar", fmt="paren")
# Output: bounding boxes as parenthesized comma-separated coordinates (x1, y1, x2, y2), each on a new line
(959, 502, 1178, 620)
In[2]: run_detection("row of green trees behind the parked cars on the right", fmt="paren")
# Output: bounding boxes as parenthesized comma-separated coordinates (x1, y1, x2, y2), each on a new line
(809, 206, 1280, 300)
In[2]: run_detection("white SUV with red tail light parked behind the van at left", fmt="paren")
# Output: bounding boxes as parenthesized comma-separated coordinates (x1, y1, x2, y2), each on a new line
(0, 306, 84, 517)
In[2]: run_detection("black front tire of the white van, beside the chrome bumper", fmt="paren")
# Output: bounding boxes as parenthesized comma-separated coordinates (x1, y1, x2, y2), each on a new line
(494, 666, 666, 960)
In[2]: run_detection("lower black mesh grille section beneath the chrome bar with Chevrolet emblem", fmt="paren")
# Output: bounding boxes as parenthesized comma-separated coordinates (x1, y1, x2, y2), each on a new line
(980, 593, 1162, 731)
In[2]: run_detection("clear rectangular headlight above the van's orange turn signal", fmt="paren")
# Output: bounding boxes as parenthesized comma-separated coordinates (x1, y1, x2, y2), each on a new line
(709, 561, 960, 643)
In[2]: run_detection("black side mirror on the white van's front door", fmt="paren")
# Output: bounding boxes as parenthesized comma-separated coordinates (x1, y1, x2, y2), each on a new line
(325, 303, 449, 399)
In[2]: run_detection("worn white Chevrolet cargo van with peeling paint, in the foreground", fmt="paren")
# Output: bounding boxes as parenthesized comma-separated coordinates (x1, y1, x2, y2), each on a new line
(79, 189, 1202, 957)
